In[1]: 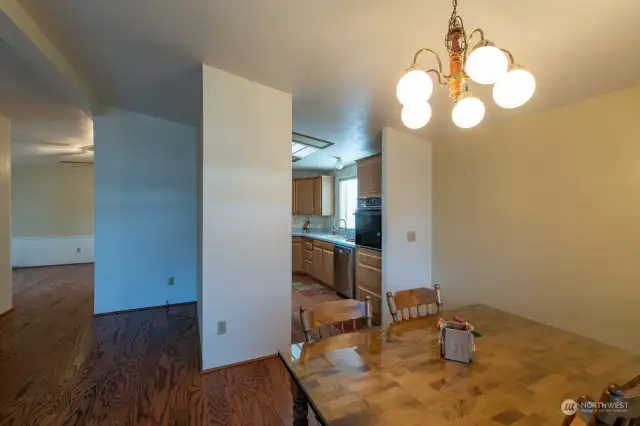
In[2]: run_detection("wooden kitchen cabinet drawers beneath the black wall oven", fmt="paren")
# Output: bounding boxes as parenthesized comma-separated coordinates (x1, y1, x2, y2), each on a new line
(356, 247, 382, 325)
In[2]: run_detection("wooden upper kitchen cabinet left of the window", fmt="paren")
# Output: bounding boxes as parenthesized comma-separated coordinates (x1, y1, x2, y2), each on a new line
(293, 176, 334, 216)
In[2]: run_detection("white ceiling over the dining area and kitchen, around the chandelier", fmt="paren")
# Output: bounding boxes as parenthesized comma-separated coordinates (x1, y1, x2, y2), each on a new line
(10, 0, 640, 168)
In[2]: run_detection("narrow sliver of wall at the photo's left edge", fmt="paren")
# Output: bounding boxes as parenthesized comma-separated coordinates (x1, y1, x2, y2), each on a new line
(0, 116, 13, 314)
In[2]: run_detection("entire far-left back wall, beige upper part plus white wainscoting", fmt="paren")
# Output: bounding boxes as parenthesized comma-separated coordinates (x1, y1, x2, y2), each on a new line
(11, 164, 94, 267)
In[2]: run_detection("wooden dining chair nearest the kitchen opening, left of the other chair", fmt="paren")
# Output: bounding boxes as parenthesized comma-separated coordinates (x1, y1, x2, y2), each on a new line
(300, 296, 371, 342)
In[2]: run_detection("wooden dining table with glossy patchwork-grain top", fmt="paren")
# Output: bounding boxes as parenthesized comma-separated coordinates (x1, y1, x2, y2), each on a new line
(279, 305, 640, 426)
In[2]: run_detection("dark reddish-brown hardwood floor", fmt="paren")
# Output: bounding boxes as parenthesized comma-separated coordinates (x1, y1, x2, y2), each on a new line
(0, 265, 330, 426)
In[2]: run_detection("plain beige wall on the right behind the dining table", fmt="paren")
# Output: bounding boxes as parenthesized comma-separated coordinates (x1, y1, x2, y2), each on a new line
(433, 86, 640, 351)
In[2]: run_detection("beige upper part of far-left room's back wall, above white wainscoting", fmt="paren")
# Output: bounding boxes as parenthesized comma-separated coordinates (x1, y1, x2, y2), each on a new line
(12, 165, 93, 237)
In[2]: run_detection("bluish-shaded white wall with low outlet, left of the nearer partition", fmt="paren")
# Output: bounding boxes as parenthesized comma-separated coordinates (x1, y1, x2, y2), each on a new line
(94, 109, 198, 313)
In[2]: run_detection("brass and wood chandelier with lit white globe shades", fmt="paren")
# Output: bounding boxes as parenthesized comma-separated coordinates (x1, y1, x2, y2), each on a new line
(396, 0, 536, 129)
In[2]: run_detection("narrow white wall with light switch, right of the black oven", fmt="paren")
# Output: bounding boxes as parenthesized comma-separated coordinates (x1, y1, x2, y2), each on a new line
(382, 127, 432, 326)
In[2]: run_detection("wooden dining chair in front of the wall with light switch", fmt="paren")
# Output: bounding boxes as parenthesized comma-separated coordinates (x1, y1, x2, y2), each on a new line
(387, 284, 442, 322)
